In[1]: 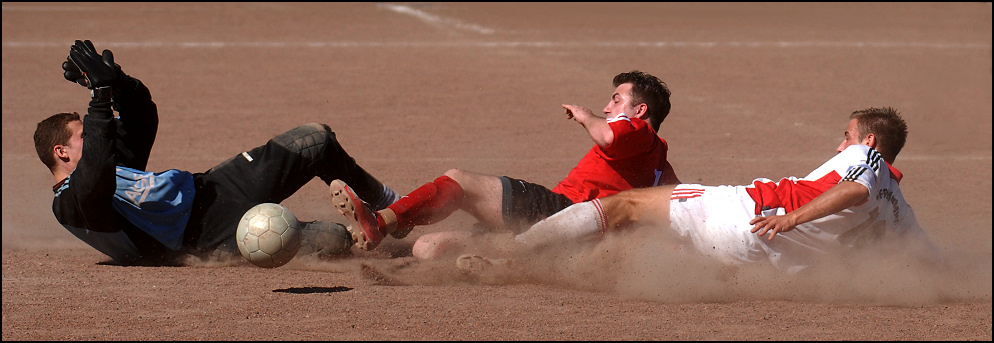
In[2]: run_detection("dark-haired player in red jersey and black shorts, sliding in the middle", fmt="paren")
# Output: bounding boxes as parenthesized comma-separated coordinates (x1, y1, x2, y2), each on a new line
(331, 71, 680, 258)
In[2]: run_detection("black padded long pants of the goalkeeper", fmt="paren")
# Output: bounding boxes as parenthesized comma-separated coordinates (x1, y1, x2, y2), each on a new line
(184, 124, 384, 254)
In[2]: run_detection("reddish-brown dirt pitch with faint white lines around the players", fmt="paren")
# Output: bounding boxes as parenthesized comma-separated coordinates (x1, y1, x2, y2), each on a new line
(2, 2, 992, 341)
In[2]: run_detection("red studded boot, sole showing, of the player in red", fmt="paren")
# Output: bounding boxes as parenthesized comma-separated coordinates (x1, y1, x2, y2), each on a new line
(330, 180, 383, 251)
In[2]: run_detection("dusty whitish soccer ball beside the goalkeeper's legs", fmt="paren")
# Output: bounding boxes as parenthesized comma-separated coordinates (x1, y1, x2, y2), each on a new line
(235, 203, 301, 268)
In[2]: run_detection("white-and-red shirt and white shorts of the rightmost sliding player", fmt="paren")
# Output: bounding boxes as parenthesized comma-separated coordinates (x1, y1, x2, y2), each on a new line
(670, 145, 934, 272)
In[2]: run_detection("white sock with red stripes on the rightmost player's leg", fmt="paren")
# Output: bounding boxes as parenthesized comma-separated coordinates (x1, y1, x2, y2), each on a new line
(514, 199, 606, 248)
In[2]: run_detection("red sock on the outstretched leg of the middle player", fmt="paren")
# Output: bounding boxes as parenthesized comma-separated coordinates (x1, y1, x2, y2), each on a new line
(387, 175, 463, 230)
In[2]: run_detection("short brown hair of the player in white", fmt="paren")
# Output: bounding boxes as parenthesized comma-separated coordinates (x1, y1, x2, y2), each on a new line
(849, 107, 908, 163)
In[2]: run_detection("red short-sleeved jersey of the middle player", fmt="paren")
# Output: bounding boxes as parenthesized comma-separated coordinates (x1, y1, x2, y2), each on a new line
(552, 114, 680, 203)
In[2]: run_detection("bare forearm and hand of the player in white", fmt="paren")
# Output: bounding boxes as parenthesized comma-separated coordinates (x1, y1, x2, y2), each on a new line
(749, 181, 870, 240)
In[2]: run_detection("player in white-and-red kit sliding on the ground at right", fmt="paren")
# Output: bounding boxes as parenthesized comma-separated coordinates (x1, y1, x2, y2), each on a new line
(457, 108, 935, 273)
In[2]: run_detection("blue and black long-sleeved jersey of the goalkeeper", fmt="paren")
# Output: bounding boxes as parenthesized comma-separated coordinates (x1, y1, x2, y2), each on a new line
(52, 77, 188, 263)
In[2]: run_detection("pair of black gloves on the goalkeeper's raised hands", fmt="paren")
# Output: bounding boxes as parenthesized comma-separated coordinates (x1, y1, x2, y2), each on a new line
(62, 40, 123, 89)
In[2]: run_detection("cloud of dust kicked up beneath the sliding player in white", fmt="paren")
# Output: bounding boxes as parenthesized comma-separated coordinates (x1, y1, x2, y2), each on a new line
(504, 229, 991, 306)
